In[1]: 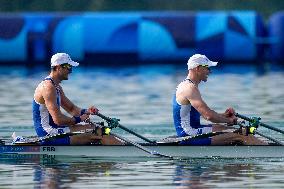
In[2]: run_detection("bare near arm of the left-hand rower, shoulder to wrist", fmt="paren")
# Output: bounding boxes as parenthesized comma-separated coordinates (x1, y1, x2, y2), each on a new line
(42, 81, 75, 126)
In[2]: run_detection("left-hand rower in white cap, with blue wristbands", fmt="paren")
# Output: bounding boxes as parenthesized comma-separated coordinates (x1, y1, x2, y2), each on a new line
(33, 53, 121, 145)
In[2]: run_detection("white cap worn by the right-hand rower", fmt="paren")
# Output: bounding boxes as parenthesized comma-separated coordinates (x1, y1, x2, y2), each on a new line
(187, 54, 218, 70)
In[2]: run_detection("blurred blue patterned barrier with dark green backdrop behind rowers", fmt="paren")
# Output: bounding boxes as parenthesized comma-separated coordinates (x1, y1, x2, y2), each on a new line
(0, 0, 284, 66)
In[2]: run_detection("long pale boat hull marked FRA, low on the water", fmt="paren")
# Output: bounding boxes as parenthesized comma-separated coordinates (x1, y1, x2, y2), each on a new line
(0, 145, 284, 158)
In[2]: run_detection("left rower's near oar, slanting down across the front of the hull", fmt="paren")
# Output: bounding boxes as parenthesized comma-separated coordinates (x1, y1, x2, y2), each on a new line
(88, 121, 173, 159)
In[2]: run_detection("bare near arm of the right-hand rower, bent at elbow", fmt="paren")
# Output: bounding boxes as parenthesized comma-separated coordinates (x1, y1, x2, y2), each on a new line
(186, 87, 231, 123)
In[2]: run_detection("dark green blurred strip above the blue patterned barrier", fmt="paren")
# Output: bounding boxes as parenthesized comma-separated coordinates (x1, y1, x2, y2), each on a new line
(0, 0, 284, 19)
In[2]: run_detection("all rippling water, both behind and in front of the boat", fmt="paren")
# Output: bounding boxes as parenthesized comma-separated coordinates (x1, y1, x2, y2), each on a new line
(0, 65, 284, 188)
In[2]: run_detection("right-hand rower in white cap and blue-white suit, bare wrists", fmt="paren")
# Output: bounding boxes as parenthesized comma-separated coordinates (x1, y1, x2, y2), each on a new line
(173, 54, 265, 145)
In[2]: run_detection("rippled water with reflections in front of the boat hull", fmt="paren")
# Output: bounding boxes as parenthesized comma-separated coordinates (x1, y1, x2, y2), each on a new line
(0, 156, 284, 188)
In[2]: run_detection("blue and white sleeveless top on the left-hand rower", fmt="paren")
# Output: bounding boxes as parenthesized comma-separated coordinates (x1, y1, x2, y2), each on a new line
(32, 77, 70, 137)
